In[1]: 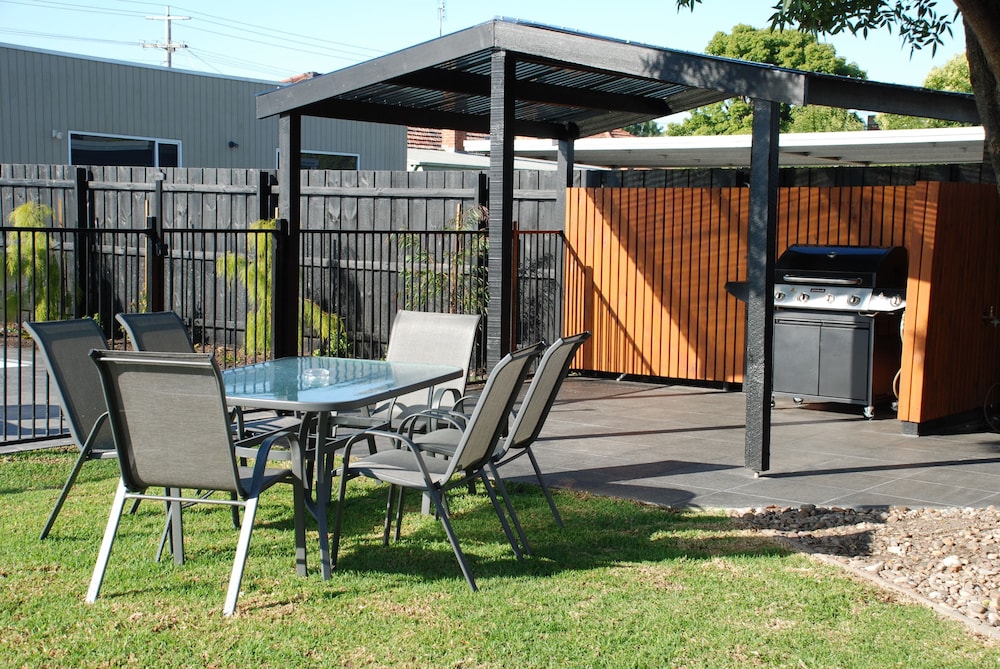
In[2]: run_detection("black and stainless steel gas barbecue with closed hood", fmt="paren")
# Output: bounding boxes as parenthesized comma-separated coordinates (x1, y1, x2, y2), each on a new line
(773, 245, 907, 418)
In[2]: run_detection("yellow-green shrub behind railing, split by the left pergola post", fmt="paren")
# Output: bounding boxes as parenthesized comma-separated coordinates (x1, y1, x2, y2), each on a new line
(216, 219, 347, 356)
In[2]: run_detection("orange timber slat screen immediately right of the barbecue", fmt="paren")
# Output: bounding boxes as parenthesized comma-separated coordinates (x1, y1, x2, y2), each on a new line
(899, 183, 1000, 423)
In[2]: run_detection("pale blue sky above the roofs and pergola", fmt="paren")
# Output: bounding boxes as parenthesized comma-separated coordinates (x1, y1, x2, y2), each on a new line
(0, 0, 965, 85)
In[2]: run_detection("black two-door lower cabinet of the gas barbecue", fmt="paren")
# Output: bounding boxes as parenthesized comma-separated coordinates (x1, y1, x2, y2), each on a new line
(772, 309, 902, 418)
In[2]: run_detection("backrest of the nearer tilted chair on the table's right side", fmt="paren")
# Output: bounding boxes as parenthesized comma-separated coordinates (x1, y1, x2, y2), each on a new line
(450, 344, 545, 472)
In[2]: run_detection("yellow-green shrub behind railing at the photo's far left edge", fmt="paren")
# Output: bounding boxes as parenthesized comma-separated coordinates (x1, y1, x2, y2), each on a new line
(4, 202, 68, 323)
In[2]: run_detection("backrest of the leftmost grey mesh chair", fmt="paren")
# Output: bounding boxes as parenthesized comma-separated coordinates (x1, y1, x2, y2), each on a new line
(24, 318, 114, 450)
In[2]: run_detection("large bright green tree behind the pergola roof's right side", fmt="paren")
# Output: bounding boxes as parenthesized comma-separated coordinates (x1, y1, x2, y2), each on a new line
(667, 24, 867, 135)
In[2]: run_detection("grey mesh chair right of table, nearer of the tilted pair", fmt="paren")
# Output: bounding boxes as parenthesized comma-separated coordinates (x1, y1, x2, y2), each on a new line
(330, 344, 543, 590)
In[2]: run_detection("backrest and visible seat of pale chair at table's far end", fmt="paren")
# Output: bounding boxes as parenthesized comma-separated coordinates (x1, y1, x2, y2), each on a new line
(385, 310, 482, 409)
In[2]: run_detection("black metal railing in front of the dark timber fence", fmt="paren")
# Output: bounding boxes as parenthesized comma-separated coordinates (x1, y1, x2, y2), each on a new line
(0, 222, 564, 444)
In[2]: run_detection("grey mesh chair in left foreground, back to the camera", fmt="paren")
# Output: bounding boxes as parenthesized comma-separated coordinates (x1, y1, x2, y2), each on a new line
(86, 351, 306, 616)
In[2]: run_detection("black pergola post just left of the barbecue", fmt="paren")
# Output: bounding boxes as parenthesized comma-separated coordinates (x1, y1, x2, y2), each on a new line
(743, 99, 781, 473)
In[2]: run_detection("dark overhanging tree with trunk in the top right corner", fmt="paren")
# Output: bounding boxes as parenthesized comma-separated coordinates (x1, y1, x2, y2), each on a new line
(676, 0, 1000, 188)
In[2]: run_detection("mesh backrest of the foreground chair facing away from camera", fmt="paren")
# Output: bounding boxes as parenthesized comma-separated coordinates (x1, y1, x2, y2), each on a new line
(90, 351, 246, 497)
